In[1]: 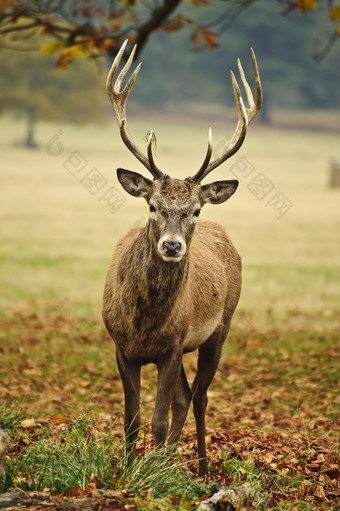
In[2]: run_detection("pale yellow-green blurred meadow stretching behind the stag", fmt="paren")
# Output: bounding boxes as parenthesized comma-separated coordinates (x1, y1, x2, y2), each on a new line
(0, 114, 340, 329)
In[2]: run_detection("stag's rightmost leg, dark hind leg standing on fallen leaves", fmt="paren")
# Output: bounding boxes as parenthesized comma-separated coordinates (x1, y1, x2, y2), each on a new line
(191, 330, 226, 476)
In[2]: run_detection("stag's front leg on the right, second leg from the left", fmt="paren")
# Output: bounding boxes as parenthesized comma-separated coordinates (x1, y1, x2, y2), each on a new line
(152, 350, 183, 447)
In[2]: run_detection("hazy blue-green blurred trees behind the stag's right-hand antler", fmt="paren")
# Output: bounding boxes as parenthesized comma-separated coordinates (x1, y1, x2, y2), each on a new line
(134, 1, 340, 117)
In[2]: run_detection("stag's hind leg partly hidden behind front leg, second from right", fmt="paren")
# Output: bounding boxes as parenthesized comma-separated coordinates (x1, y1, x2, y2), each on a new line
(169, 364, 192, 445)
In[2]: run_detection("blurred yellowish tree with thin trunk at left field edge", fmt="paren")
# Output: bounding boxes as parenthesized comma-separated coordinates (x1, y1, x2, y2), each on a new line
(0, 48, 106, 147)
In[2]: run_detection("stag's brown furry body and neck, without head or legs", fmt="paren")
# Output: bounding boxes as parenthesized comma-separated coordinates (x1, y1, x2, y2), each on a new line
(103, 220, 241, 364)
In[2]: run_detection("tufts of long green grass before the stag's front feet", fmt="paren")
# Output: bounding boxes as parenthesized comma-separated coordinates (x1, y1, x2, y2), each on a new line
(4, 411, 194, 499)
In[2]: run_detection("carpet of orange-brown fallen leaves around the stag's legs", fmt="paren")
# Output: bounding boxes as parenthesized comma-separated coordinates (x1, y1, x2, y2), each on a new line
(0, 311, 340, 511)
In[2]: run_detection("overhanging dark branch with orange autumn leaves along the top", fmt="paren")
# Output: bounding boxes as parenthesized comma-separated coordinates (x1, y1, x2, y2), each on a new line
(0, 0, 340, 63)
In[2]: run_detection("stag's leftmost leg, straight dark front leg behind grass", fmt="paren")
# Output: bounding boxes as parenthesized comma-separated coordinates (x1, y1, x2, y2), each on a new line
(116, 347, 141, 465)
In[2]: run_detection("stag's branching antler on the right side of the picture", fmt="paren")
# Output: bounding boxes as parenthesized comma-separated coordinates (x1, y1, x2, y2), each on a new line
(192, 48, 262, 183)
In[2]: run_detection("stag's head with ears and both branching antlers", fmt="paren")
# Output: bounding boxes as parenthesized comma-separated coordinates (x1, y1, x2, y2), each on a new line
(106, 41, 262, 262)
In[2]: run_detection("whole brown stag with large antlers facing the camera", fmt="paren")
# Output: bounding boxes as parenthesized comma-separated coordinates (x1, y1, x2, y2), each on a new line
(103, 41, 262, 475)
